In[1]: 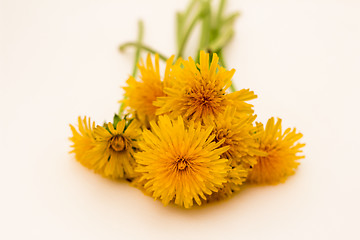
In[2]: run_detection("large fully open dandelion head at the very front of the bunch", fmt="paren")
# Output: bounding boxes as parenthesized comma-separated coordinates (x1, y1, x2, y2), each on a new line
(135, 115, 229, 208)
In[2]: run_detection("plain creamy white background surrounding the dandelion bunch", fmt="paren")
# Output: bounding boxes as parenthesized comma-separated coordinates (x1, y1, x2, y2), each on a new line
(0, 0, 360, 239)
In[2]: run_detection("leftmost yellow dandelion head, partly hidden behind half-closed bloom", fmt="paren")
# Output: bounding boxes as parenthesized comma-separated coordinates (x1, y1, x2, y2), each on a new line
(69, 117, 96, 167)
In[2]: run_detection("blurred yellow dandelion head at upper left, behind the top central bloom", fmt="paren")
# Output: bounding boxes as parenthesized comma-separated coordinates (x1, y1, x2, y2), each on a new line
(120, 54, 179, 127)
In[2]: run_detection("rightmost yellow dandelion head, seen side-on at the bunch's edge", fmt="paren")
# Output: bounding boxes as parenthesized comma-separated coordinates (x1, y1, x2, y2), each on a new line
(248, 118, 305, 184)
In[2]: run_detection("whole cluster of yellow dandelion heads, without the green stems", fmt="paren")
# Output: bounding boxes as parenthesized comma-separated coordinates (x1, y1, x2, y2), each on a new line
(70, 52, 304, 208)
